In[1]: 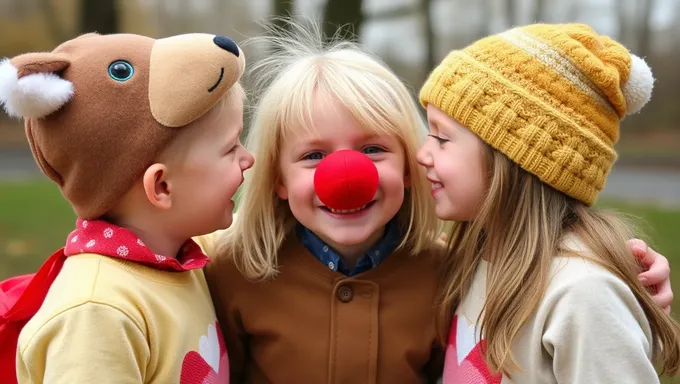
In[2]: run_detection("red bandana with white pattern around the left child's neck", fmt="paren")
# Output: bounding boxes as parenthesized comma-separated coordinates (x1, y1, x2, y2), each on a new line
(64, 219, 210, 271)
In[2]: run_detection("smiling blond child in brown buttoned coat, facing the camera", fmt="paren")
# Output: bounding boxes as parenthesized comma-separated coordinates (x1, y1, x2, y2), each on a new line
(201, 23, 670, 383)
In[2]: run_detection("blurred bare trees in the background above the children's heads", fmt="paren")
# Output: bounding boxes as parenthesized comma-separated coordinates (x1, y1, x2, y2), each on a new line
(0, 0, 680, 161)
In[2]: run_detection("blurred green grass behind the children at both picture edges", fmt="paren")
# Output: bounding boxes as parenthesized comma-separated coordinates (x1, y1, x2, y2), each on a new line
(0, 180, 680, 382)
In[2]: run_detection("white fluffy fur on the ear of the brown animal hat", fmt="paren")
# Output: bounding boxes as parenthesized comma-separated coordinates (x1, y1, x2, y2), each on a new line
(0, 59, 73, 118)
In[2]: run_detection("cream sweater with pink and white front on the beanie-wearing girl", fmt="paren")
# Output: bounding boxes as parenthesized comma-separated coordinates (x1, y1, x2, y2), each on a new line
(443, 237, 659, 384)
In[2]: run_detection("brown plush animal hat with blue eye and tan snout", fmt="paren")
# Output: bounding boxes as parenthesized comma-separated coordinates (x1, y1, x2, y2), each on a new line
(0, 34, 245, 219)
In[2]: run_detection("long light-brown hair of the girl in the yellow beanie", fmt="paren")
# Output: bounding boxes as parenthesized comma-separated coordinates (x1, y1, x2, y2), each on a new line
(437, 145, 680, 376)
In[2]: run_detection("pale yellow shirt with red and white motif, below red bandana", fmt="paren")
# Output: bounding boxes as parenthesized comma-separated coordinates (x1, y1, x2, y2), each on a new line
(17, 254, 229, 384)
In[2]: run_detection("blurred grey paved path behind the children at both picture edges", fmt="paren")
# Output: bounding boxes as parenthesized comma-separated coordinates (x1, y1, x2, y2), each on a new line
(0, 148, 680, 208)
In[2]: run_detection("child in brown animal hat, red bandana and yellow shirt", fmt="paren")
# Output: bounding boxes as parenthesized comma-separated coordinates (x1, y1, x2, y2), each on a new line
(0, 34, 253, 383)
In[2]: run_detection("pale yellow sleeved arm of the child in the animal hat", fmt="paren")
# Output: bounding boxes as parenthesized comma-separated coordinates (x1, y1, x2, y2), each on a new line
(17, 302, 150, 384)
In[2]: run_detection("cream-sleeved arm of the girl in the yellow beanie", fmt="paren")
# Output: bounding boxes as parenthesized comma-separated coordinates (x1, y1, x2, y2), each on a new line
(542, 273, 659, 383)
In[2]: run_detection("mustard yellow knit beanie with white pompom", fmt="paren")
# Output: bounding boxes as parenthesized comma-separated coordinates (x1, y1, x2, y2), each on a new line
(420, 24, 654, 205)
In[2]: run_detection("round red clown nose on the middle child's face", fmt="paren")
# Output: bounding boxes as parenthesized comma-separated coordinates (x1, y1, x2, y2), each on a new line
(314, 149, 378, 210)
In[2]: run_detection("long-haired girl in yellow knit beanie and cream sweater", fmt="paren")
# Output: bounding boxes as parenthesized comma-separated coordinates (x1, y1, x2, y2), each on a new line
(418, 24, 680, 383)
